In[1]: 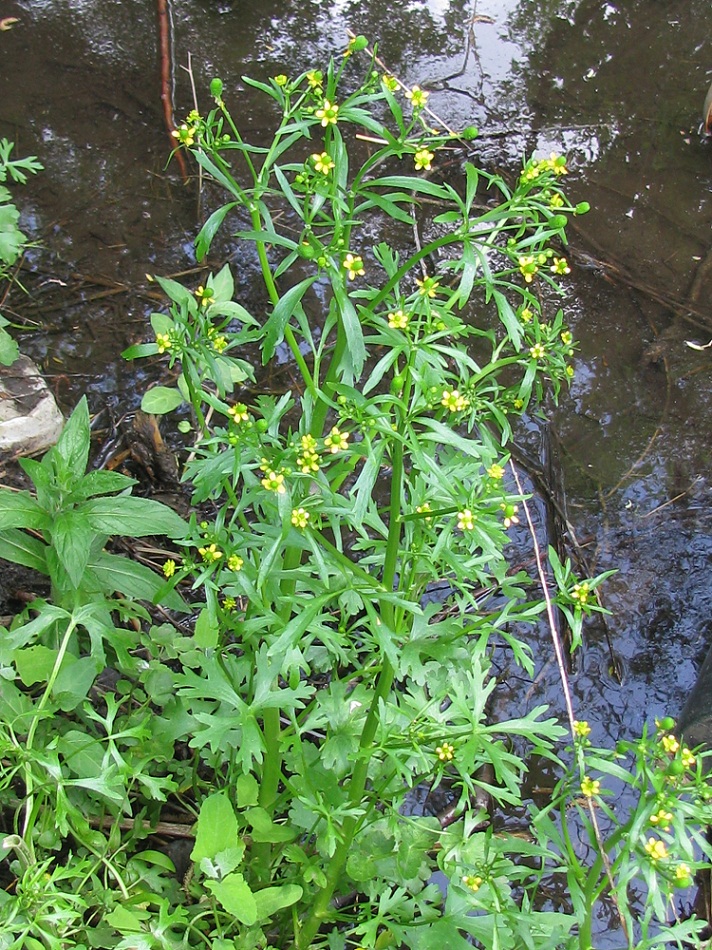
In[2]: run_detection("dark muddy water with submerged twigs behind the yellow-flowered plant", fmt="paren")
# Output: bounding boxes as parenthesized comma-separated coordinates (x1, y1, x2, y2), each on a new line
(0, 0, 712, 936)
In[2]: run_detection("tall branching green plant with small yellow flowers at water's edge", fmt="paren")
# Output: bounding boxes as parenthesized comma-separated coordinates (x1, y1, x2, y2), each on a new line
(111, 39, 705, 950)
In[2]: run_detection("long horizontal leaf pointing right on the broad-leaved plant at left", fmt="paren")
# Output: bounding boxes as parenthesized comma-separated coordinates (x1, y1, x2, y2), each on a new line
(78, 495, 188, 538)
